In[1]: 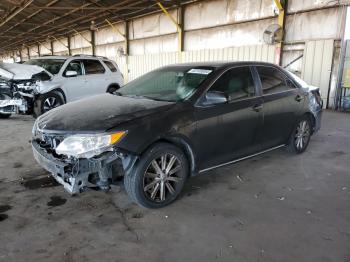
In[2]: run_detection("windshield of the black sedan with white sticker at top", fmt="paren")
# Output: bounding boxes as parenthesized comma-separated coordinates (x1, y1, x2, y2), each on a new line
(118, 67, 214, 102)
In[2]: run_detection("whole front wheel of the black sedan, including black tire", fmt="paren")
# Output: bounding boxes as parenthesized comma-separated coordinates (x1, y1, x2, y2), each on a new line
(124, 143, 189, 208)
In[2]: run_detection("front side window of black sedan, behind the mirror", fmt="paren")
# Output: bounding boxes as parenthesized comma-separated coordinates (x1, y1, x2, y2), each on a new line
(210, 67, 255, 101)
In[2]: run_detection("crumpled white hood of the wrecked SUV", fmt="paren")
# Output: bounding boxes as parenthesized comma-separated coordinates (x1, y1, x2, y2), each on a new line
(0, 63, 52, 80)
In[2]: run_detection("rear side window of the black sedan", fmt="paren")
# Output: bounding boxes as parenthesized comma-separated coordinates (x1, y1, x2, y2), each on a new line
(256, 66, 295, 95)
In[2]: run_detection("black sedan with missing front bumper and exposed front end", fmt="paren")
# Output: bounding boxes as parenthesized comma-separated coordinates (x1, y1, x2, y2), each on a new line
(32, 62, 322, 208)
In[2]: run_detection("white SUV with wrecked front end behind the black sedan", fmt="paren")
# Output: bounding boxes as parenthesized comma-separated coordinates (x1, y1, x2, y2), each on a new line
(0, 55, 124, 116)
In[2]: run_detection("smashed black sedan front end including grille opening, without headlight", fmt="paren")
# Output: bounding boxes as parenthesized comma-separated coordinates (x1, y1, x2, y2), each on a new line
(32, 125, 137, 195)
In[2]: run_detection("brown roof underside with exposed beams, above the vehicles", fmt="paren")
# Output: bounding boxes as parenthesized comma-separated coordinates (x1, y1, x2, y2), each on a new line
(0, 0, 194, 55)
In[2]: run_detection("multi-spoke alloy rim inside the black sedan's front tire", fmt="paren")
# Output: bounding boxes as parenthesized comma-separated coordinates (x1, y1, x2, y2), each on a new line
(143, 154, 183, 203)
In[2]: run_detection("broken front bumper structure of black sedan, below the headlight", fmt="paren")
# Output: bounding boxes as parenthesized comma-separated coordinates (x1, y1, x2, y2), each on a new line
(32, 140, 136, 195)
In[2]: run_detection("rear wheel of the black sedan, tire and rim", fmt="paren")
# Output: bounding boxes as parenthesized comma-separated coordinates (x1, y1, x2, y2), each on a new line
(287, 116, 312, 154)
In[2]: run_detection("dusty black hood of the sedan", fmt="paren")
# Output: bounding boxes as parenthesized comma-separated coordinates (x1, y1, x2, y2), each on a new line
(35, 94, 175, 133)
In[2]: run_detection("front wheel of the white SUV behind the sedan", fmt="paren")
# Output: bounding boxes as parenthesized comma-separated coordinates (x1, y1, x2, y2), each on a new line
(33, 91, 64, 118)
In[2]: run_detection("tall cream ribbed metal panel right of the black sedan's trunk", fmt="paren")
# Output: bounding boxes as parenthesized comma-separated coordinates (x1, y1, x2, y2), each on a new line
(301, 39, 334, 106)
